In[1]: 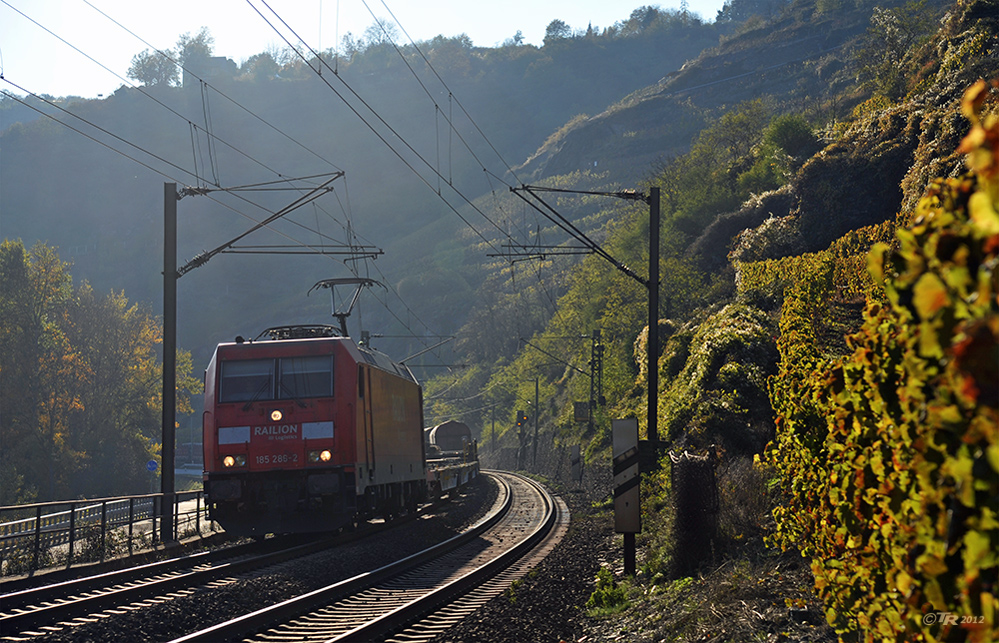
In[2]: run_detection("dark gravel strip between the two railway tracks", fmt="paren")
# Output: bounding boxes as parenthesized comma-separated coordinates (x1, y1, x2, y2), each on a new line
(32, 477, 497, 643)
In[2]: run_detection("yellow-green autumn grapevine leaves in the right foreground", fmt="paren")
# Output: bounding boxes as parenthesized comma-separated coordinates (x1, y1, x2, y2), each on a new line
(767, 83, 999, 641)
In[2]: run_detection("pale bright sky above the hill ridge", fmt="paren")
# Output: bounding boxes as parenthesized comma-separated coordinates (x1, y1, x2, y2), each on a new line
(0, 0, 724, 97)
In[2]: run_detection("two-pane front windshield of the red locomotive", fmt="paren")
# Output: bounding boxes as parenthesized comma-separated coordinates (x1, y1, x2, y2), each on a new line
(219, 355, 333, 404)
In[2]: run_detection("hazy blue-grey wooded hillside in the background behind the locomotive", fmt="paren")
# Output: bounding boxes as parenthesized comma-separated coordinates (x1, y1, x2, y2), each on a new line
(0, 8, 719, 372)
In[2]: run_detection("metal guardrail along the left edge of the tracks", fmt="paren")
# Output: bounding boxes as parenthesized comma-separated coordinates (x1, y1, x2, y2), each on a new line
(0, 490, 215, 575)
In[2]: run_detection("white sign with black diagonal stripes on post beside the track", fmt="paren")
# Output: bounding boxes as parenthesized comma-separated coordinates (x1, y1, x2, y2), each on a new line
(611, 418, 642, 576)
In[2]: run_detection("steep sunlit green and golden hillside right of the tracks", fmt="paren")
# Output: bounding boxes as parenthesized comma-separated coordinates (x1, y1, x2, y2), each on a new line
(440, 0, 999, 642)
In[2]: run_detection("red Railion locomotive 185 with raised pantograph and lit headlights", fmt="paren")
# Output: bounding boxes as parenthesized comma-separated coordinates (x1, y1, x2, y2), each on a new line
(203, 279, 478, 536)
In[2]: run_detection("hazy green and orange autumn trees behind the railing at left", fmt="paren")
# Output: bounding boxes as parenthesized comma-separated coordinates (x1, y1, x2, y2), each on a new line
(0, 241, 201, 504)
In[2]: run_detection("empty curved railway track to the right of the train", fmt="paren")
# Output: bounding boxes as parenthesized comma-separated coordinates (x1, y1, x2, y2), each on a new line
(173, 472, 568, 643)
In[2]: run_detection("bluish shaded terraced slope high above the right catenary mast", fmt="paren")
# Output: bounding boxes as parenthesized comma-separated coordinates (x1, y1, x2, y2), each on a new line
(518, 2, 945, 183)
